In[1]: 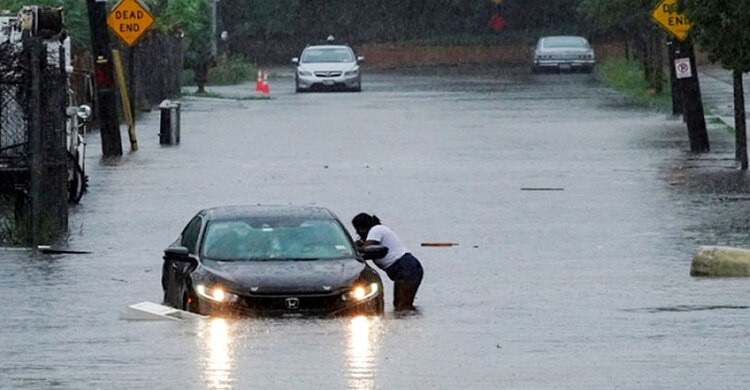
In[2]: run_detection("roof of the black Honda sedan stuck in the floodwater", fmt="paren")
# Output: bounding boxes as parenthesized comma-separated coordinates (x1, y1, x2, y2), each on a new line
(202, 205, 337, 220)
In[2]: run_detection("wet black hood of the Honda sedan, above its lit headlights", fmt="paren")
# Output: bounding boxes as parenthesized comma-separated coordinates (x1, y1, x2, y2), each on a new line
(201, 259, 366, 294)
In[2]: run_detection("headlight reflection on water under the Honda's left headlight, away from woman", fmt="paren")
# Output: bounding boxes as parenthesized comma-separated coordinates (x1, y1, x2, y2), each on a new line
(198, 318, 234, 389)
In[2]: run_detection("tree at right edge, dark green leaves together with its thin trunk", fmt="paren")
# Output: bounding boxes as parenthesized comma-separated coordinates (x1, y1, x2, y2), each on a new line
(677, 0, 750, 170)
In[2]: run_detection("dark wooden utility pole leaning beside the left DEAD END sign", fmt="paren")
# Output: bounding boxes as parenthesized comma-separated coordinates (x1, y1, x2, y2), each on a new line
(86, 0, 122, 157)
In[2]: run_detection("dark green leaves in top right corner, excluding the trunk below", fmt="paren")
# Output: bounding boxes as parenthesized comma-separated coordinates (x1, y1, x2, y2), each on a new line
(678, 0, 750, 73)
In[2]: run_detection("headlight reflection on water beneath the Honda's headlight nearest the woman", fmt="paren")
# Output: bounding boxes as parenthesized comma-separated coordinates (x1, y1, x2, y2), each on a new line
(347, 316, 382, 390)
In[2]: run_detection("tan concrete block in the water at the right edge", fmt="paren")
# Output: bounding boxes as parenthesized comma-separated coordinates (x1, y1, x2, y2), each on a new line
(690, 246, 750, 277)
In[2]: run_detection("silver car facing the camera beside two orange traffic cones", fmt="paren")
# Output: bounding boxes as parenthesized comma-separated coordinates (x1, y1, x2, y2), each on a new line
(292, 44, 364, 92)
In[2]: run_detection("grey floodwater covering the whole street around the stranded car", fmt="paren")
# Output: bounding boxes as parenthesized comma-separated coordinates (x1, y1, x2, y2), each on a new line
(0, 69, 750, 390)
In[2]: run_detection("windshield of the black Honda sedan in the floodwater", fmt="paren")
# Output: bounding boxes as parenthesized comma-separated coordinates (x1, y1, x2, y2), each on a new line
(202, 219, 354, 261)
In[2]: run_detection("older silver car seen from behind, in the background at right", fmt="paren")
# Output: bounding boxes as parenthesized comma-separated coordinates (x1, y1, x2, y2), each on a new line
(532, 35, 596, 73)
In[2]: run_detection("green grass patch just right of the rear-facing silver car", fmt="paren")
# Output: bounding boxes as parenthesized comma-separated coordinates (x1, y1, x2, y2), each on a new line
(596, 59, 672, 110)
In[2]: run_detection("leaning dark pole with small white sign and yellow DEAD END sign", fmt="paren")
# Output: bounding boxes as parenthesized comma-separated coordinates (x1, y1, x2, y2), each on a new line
(651, 0, 711, 153)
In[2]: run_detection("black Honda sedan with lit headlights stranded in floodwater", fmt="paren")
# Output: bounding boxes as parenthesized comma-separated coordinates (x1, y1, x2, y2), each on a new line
(162, 206, 386, 315)
